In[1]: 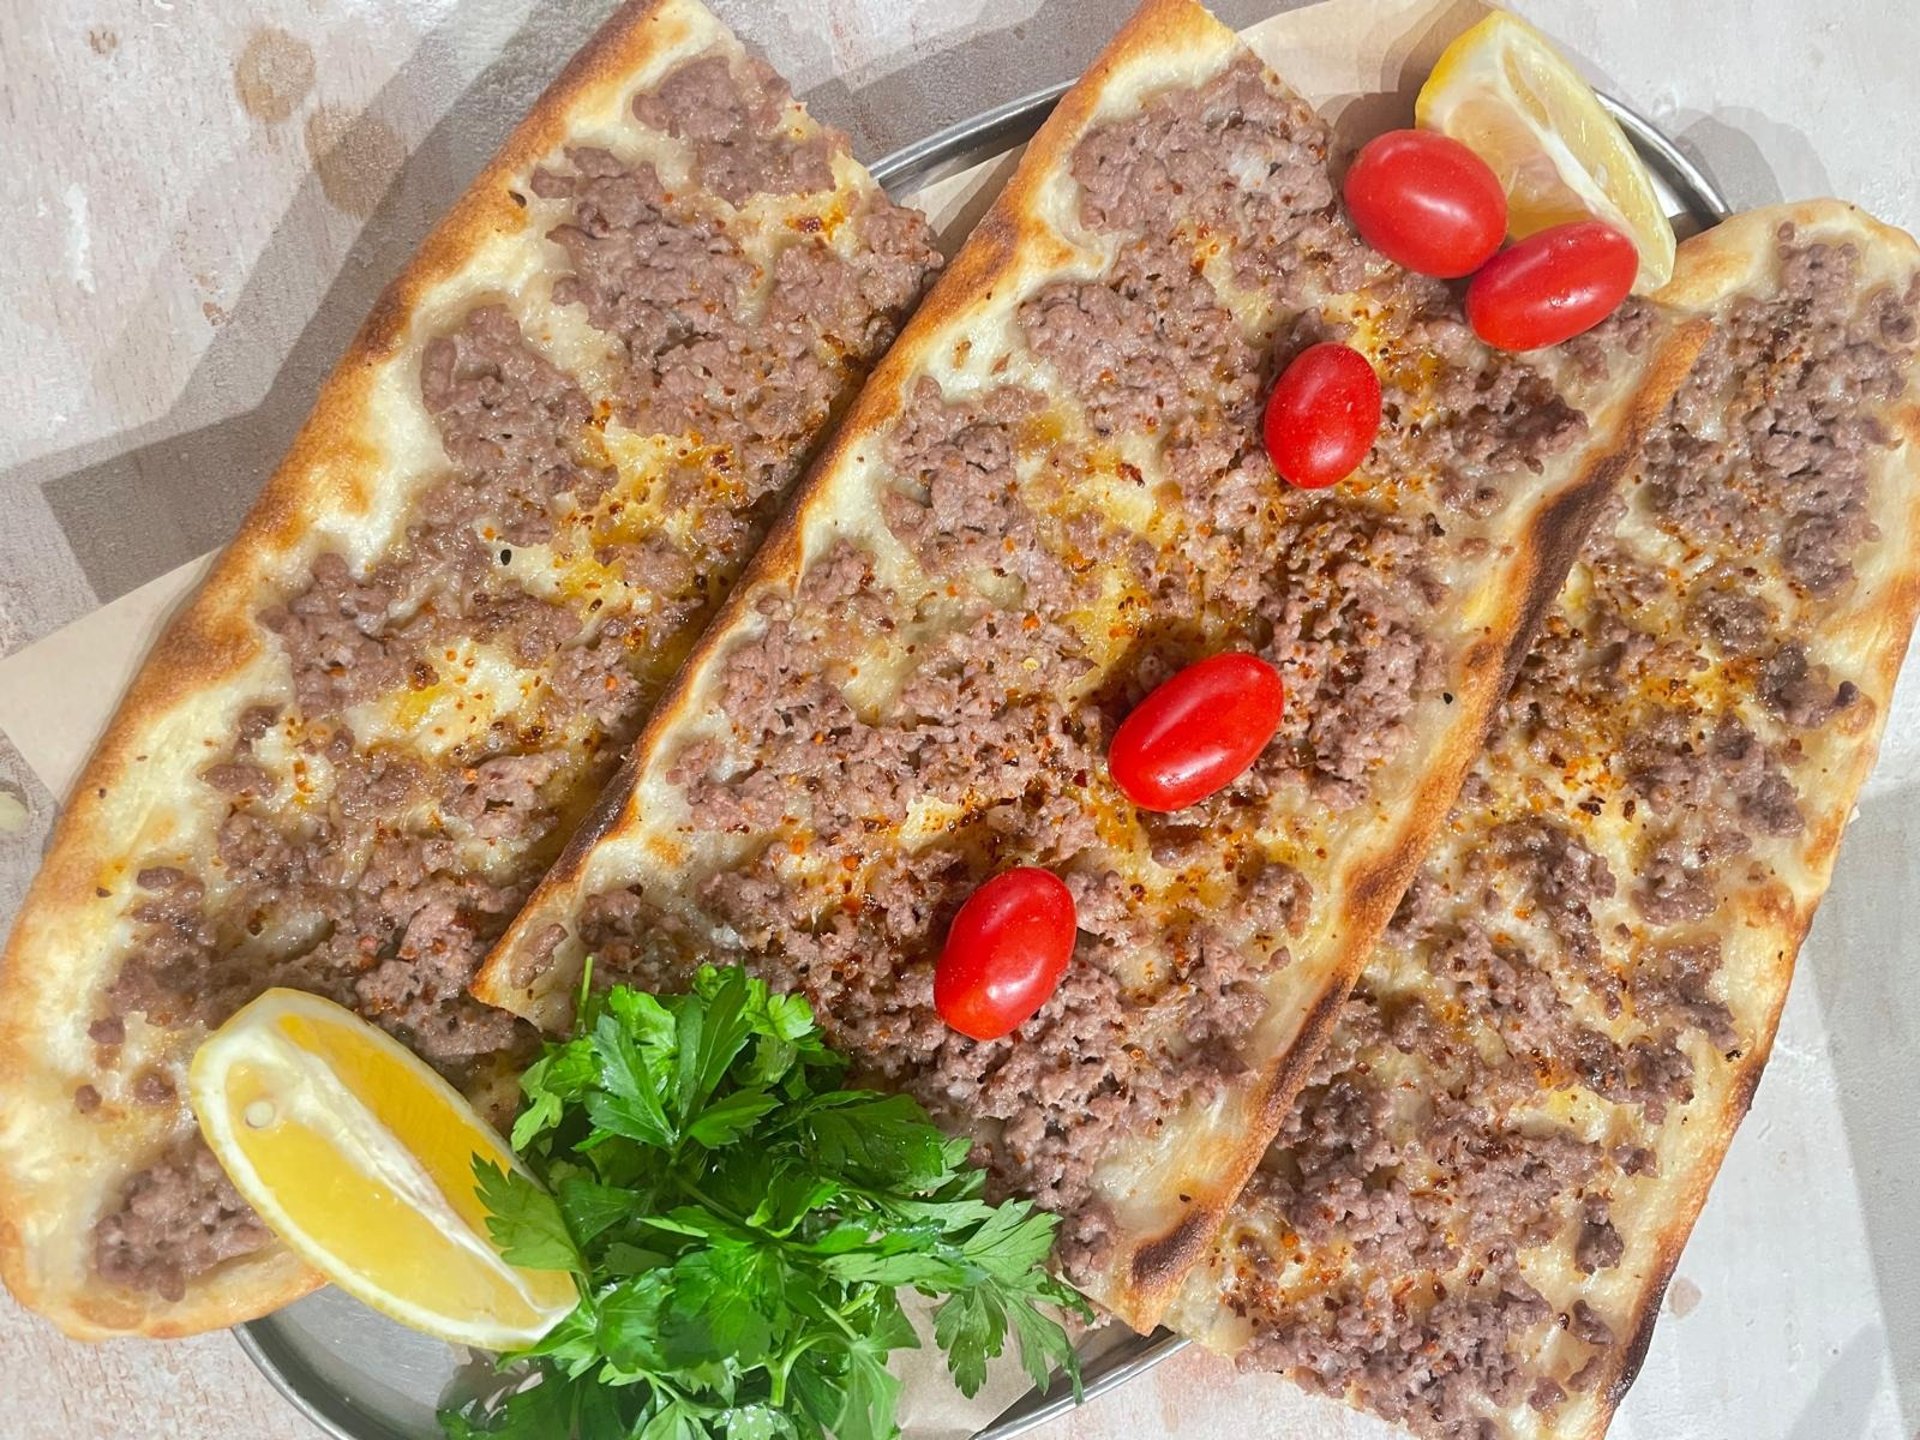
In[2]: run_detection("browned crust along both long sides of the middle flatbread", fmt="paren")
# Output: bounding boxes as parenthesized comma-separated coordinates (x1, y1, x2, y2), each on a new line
(474, 0, 1705, 1331)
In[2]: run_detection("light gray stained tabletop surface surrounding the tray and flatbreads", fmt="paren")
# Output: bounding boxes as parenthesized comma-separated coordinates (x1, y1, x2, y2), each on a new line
(0, 0, 1920, 1440)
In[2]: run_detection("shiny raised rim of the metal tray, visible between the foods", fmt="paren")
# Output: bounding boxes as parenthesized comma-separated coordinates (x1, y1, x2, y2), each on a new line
(230, 81, 1732, 1440)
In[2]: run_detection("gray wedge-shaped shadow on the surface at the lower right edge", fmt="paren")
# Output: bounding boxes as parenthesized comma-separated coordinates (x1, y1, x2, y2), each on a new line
(1797, 787, 1920, 1440)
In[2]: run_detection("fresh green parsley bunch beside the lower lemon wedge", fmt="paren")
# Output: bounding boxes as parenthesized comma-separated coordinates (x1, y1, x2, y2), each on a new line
(442, 968, 1089, 1440)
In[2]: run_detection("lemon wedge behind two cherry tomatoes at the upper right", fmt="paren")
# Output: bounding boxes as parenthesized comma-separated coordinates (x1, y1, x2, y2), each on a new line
(1413, 10, 1674, 294)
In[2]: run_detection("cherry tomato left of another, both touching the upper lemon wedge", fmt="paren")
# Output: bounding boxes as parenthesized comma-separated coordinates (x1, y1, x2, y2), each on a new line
(1344, 131, 1507, 280)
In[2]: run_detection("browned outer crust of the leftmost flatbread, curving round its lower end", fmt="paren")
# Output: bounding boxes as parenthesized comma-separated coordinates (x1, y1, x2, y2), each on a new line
(0, 0, 756, 1338)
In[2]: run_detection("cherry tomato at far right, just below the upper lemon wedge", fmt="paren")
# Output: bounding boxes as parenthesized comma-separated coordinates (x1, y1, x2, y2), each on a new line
(1467, 221, 1640, 349)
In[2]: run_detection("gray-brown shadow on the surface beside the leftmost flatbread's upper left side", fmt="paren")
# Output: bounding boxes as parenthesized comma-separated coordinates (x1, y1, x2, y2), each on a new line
(0, 0, 611, 605)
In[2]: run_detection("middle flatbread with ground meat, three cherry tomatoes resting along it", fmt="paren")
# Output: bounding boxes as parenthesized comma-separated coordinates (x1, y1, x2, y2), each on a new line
(476, 0, 1697, 1329)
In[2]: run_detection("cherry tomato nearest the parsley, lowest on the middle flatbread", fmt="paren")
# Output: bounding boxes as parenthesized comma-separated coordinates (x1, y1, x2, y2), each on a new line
(933, 866, 1075, 1041)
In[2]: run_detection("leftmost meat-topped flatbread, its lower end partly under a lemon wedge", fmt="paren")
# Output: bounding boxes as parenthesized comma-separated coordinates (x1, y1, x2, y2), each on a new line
(0, 0, 937, 1336)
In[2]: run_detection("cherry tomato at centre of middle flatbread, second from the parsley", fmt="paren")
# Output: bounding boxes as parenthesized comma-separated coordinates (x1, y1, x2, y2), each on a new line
(1106, 651, 1284, 810)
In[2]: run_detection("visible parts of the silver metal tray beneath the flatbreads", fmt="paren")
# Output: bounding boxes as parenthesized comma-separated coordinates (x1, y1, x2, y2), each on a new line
(234, 84, 1732, 1440)
